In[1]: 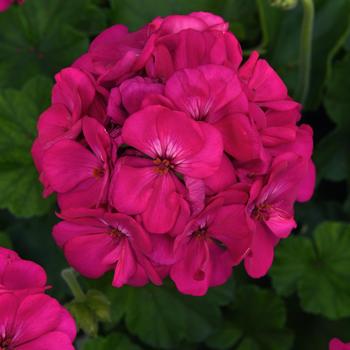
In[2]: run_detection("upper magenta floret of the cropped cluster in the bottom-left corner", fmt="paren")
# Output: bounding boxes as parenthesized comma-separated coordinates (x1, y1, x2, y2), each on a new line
(0, 247, 47, 295)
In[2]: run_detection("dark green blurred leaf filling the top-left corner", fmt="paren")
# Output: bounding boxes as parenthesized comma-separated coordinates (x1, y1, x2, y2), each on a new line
(0, 0, 106, 87)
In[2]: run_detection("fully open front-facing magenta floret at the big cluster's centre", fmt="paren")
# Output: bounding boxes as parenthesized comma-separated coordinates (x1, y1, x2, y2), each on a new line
(110, 106, 223, 233)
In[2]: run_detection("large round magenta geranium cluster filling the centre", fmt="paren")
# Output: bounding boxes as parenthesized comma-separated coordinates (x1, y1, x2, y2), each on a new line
(32, 12, 315, 295)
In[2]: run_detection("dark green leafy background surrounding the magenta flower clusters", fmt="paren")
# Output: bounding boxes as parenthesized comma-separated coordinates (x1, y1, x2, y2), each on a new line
(0, 0, 350, 350)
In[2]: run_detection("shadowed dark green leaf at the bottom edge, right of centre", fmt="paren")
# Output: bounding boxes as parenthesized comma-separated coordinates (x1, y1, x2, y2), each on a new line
(207, 286, 293, 350)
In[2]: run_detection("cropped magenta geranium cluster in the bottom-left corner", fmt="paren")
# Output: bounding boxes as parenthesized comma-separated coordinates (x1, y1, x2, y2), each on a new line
(0, 247, 76, 350)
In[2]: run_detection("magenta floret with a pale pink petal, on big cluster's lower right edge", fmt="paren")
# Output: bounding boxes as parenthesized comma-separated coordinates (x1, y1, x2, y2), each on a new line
(245, 153, 313, 278)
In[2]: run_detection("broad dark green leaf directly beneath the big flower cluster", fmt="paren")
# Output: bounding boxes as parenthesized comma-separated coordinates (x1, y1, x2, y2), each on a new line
(85, 279, 233, 349)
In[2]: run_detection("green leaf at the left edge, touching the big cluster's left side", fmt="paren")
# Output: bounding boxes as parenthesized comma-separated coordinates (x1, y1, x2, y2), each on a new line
(0, 77, 53, 217)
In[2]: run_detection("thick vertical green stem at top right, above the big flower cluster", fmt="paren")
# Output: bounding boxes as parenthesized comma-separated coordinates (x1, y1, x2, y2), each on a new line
(296, 0, 315, 104)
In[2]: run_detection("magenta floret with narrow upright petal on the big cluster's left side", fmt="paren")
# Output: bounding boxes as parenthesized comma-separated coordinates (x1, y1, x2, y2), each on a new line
(43, 117, 111, 208)
